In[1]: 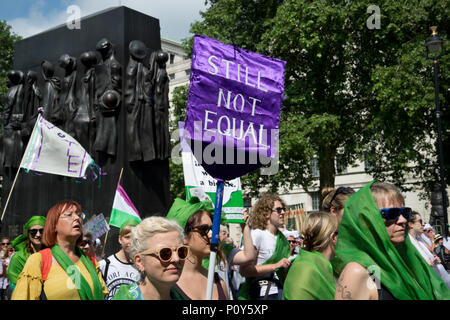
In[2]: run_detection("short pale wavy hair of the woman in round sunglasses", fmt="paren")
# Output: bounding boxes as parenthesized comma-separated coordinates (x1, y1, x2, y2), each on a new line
(130, 216, 184, 258)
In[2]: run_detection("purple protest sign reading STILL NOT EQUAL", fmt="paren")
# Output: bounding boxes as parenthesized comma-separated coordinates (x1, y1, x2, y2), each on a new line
(184, 35, 286, 180)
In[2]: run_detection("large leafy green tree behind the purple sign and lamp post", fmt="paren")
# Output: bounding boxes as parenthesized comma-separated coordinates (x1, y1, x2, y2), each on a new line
(178, 0, 450, 200)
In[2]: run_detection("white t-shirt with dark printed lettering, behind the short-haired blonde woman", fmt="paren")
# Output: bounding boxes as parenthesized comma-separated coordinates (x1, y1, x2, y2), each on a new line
(99, 254, 140, 300)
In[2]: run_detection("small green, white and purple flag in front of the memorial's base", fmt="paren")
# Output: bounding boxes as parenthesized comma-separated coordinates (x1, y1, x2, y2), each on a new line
(109, 181, 142, 228)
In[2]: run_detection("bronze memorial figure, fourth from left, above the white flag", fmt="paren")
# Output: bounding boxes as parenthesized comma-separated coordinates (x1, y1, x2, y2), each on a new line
(58, 54, 78, 137)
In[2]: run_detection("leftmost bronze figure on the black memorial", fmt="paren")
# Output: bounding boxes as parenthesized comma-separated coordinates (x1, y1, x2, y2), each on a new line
(1, 70, 25, 168)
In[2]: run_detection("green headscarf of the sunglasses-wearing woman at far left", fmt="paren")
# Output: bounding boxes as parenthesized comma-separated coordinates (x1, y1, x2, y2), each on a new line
(8, 216, 46, 287)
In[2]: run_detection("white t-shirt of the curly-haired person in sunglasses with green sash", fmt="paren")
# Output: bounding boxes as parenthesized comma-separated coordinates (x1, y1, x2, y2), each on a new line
(251, 229, 278, 296)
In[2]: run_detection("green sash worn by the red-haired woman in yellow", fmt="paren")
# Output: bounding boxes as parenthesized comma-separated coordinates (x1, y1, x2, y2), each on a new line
(52, 244, 104, 300)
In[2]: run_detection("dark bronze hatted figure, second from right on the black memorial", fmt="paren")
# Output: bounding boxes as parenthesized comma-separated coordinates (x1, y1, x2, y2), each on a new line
(125, 40, 155, 161)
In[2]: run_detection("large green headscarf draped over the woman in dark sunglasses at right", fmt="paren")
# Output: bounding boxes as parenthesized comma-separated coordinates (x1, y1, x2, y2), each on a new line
(332, 180, 450, 300)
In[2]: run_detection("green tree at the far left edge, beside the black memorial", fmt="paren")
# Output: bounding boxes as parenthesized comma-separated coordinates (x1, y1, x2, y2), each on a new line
(0, 21, 21, 118)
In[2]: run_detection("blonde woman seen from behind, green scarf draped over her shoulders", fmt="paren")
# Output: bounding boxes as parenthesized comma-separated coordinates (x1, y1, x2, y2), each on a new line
(283, 211, 338, 300)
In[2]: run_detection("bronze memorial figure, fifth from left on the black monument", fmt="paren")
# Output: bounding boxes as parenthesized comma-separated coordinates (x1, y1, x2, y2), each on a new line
(73, 51, 97, 153)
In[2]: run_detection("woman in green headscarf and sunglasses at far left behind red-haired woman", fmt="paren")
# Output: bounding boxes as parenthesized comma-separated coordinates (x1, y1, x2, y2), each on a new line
(8, 216, 45, 291)
